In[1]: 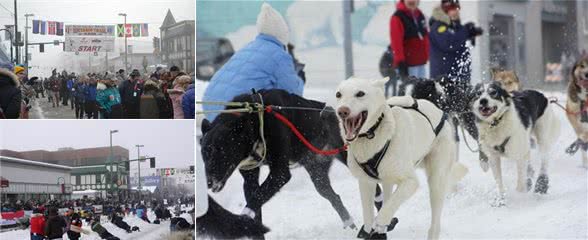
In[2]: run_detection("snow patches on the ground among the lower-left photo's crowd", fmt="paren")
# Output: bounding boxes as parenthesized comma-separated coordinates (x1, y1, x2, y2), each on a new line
(0, 208, 192, 240)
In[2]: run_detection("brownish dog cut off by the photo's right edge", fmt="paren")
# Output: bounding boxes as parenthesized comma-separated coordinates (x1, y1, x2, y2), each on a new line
(566, 56, 588, 168)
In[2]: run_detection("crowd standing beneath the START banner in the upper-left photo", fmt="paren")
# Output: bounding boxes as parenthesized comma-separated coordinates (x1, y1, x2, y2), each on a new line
(0, 65, 195, 119)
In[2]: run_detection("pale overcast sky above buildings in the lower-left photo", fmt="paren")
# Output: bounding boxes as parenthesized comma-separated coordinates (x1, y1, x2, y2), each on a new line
(0, 120, 195, 168)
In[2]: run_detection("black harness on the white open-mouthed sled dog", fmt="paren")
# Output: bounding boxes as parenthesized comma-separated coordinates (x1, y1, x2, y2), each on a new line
(353, 99, 448, 180)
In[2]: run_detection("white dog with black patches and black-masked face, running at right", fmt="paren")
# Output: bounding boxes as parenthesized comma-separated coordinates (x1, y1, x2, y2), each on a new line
(470, 82, 560, 206)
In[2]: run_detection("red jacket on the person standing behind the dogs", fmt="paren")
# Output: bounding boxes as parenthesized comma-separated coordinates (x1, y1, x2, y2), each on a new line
(390, 1, 429, 67)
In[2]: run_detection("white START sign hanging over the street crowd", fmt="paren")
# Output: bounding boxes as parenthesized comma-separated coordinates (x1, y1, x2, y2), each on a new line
(65, 36, 114, 53)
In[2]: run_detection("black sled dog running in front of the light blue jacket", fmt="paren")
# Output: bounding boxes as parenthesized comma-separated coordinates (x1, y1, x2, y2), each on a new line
(201, 90, 355, 228)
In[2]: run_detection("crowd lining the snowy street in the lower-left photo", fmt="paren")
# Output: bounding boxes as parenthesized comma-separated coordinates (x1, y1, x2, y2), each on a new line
(1, 195, 194, 240)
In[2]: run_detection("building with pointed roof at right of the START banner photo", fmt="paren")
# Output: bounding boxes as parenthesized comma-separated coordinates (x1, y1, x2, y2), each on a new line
(160, 10, 196, 73)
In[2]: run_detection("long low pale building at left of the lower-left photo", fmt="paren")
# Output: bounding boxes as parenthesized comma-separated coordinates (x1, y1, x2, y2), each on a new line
(0, 156, 72, 201)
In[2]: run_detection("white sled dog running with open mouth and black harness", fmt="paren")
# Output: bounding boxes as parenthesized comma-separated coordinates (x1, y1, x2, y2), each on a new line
(336, 78, 467, 239)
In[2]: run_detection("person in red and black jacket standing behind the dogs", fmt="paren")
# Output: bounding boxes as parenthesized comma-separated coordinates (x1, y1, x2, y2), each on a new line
(390, 0, 429, 79)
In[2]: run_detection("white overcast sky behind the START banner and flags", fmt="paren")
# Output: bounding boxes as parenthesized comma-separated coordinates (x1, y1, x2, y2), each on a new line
(0, 0, 196, 75)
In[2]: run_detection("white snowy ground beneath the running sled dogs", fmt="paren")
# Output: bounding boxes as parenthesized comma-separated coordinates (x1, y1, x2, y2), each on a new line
(196, 87, 588, 239)
